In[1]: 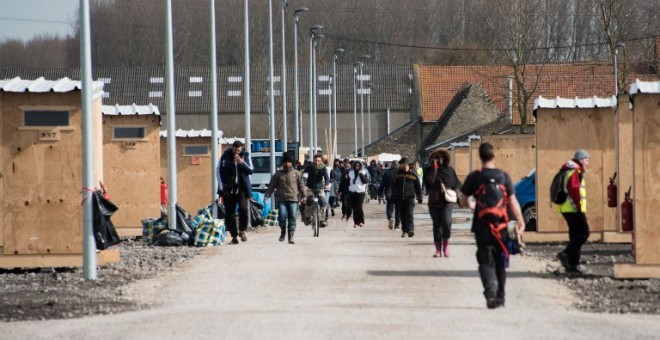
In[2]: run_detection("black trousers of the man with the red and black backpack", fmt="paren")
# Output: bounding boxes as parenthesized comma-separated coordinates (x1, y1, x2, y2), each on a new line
(474, 226, 506, 302)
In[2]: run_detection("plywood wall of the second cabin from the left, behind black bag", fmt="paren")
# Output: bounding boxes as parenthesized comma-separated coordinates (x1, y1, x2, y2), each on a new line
(103, 115, 160, 228)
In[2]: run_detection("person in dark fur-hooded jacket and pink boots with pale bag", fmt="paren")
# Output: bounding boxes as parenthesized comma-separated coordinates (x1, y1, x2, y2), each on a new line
(424, 149, 458, 257)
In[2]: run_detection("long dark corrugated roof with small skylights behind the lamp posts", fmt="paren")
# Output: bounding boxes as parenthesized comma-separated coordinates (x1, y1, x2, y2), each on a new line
(0, 64, 412, 114)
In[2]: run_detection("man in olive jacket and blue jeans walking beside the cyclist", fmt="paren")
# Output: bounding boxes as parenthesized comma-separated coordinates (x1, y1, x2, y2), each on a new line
(264, 153, 306, 244)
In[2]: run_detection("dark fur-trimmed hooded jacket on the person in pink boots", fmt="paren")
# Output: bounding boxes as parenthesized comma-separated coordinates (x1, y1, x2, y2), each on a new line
(423, 149, 458, 208)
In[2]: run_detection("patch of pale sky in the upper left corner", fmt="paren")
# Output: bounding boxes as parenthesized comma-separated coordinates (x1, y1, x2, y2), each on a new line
(0, 0, 78, 41)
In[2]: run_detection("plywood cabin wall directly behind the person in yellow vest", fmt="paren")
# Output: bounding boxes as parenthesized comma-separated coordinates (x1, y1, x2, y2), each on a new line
(536, 108, 615, 232)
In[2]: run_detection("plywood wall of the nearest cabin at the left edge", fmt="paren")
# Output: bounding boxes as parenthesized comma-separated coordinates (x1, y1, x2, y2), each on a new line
(0, 92, 103, 254)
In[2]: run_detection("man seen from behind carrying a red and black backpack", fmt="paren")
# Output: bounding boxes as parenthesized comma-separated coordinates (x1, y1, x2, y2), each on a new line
(460, 143, 525, 309)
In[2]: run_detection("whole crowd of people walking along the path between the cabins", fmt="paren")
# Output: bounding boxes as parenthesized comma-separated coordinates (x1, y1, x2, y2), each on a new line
(218, 141, 590, 309)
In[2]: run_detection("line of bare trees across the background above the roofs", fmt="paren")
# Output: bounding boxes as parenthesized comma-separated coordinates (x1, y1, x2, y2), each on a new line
(0, 0, 660, 68)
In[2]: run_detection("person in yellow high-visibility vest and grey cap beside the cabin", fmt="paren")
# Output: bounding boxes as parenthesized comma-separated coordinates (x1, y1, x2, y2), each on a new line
(557, 149, 590, 272)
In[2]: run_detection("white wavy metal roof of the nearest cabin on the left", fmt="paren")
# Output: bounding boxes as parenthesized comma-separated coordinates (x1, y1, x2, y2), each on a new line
(0, 77, 103, 98)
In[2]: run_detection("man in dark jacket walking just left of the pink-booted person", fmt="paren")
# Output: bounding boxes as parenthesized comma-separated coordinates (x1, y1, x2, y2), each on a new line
(392, 157, 422, 237)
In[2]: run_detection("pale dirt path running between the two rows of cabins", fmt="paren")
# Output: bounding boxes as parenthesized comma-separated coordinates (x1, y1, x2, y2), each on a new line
(0, 202, 660, 340)
